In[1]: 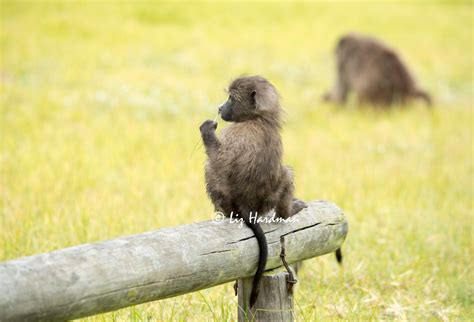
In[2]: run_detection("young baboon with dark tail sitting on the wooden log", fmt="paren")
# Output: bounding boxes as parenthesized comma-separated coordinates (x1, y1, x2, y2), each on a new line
(200, 76, 305, 307)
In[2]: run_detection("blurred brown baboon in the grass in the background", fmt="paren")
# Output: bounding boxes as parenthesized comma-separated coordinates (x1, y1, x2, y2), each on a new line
(324, 34, 431, 106)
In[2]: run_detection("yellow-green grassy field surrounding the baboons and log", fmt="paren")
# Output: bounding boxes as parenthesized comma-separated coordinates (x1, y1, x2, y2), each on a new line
(0, 1, 474, 321)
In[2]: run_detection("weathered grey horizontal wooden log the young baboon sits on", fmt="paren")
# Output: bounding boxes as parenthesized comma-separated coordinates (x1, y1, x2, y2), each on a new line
(0, 201, 347, 321)
